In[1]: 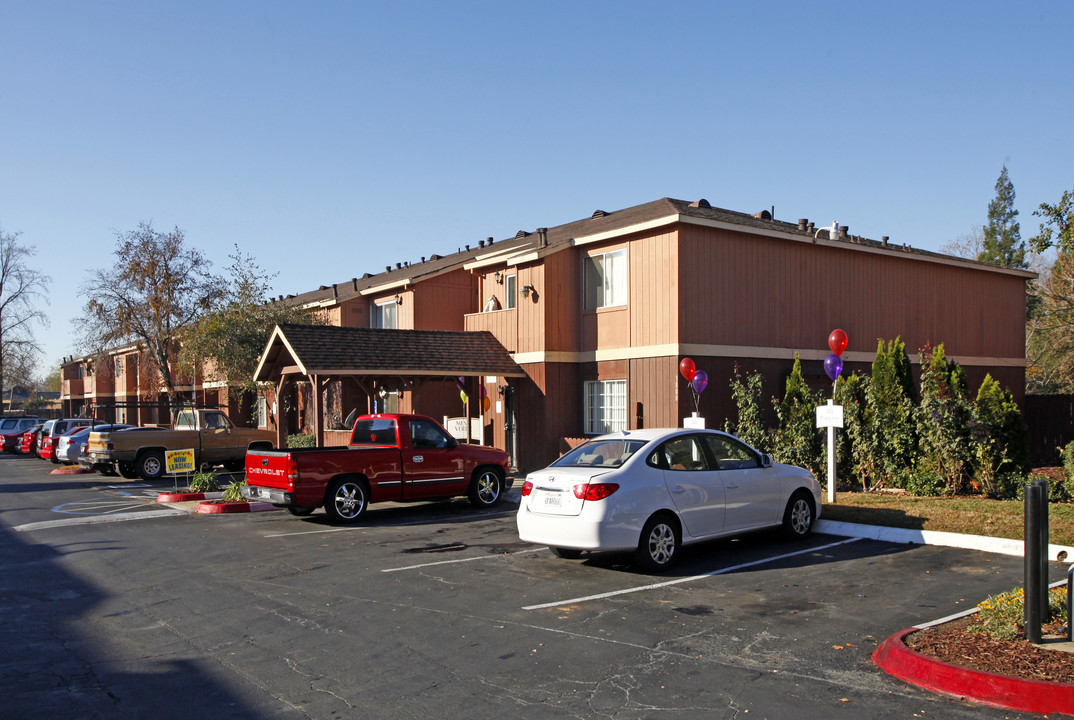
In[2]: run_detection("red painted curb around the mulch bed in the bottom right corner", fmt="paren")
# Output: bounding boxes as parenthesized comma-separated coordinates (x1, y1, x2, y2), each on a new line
(872, 628, 1074, 715)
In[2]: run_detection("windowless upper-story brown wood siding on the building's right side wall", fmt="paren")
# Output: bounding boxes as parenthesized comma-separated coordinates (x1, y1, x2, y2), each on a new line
(678, 226, 1025, 358)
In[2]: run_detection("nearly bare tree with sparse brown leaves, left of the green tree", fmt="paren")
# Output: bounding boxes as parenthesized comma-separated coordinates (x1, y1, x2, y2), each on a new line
(79, 222, 221, 400)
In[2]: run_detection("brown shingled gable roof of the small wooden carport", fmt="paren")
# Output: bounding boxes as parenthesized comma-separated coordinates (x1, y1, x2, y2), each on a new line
(255, 325, 525, 381)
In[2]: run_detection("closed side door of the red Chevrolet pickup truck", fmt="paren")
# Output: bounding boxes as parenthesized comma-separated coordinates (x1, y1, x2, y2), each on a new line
(403, 419, 469, 499)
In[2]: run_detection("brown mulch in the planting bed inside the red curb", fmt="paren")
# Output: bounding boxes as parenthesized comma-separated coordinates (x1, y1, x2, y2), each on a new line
(906, 616, 1074, 682)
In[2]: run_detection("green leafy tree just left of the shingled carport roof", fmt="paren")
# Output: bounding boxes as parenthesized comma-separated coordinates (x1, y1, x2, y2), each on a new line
(180, 246, 322, 392)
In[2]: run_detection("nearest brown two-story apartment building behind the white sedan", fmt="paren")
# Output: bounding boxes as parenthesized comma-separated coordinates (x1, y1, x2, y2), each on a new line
(60, 198, 1033, 470)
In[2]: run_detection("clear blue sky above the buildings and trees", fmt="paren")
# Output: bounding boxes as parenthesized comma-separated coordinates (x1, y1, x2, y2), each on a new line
(0, 0, 1074, 375)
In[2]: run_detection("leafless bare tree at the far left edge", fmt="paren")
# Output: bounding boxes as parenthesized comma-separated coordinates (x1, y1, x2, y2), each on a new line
(0, 229, 52, 408)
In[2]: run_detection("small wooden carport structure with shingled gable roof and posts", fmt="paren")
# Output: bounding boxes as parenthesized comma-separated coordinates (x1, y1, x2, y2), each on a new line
(253, 325, 526, 447)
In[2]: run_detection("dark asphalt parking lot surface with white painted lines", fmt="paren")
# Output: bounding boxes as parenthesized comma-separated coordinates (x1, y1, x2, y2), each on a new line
(0, 456, 1063, 719)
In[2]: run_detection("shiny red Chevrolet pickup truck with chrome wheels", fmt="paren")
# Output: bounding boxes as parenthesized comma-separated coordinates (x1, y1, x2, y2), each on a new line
(243, 415, 508, 522)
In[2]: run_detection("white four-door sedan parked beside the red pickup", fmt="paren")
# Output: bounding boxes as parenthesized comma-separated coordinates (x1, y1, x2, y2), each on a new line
(518, 429, 821, 572)
